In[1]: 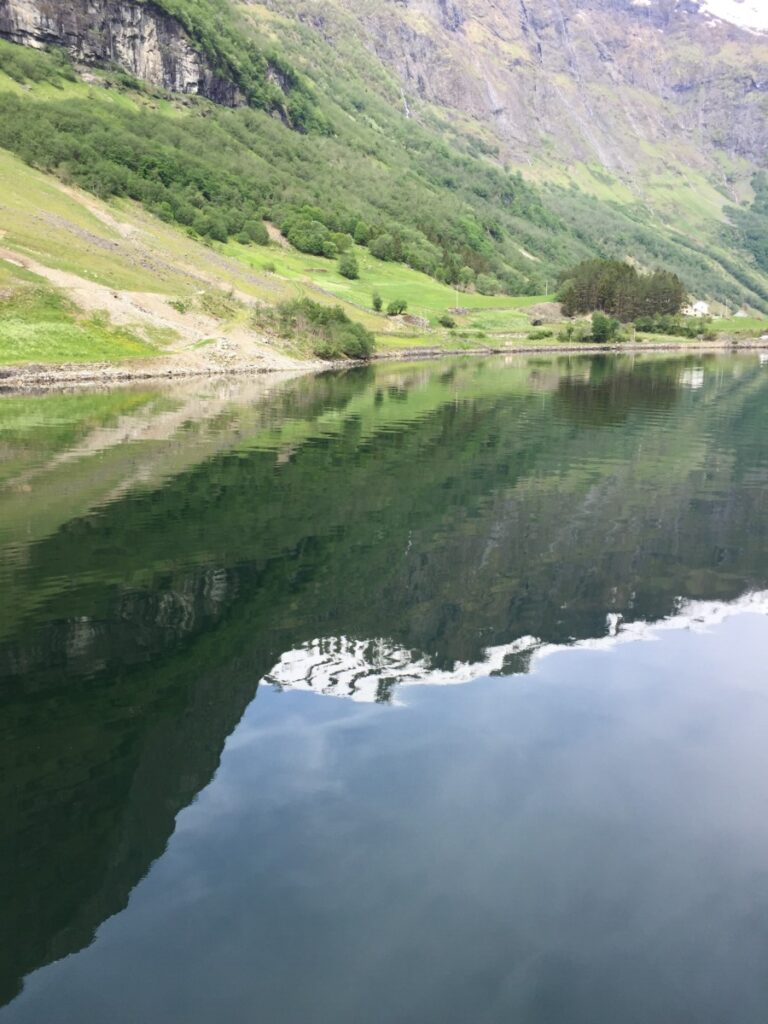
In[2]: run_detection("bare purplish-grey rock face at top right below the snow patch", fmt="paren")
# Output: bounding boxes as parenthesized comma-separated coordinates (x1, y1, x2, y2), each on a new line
(315, 0, 768, 173)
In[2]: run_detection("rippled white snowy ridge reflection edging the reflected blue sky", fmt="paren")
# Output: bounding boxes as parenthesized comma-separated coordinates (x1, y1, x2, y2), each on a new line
(262, 591, 768, 702)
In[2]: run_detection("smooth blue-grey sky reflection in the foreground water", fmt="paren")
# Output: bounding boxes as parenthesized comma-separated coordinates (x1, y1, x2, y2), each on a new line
(9, 609, 768, 1024)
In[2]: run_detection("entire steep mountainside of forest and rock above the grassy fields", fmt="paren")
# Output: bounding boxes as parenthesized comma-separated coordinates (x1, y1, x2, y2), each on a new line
(0, 0, 768, 348)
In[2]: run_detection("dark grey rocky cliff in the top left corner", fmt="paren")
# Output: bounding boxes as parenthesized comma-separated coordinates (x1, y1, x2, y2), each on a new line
(0, 0, 245, 106)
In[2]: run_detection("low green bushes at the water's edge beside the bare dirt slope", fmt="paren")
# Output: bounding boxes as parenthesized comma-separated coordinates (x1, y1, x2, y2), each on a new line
(253, 299, 376, 359)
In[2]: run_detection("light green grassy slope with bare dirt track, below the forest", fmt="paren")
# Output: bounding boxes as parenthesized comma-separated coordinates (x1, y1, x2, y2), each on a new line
(0, 144, 528, 365)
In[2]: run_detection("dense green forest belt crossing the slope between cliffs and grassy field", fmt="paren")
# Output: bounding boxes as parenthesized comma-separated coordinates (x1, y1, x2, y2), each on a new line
(0, 24, 768, 307)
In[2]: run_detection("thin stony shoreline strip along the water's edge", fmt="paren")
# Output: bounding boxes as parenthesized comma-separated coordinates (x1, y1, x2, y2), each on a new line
(0, 341, 768, 395)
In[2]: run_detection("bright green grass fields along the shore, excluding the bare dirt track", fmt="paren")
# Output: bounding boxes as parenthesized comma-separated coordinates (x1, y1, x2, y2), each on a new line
(0, 138, 768, 365)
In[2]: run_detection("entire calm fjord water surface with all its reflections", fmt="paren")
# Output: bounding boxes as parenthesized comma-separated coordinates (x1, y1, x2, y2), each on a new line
(0, 354, 768, 1024)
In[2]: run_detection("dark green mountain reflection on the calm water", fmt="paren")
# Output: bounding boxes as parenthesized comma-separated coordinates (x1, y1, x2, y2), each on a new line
(0, 359, 768, 999)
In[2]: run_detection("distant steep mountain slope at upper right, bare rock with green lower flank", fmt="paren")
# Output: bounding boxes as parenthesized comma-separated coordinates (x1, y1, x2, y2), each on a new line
(250, 0, 768, 300)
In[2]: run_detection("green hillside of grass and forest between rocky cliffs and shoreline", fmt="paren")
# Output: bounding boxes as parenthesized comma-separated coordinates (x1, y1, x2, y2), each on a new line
(0, 0, 768, 365)
